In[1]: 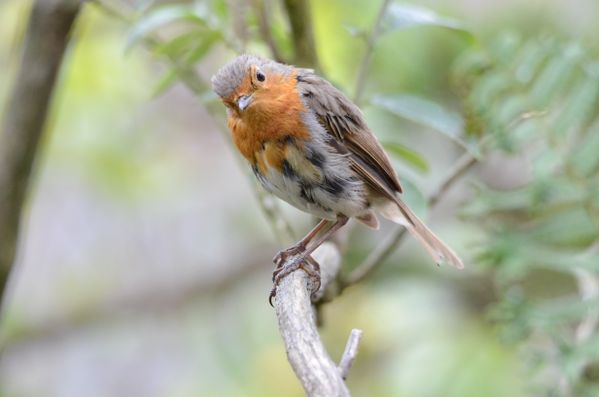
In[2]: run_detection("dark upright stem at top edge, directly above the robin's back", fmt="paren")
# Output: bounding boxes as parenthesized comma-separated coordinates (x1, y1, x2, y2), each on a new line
(283, 0, 320, 69)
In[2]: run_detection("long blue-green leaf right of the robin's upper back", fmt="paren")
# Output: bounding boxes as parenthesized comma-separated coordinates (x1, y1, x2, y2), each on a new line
(371, 95, 476, 153)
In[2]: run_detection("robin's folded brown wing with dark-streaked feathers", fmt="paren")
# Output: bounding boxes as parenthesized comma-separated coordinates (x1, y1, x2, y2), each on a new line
(297, 69, 402, 200)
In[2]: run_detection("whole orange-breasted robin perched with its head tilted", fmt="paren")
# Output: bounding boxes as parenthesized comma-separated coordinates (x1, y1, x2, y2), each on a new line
(211, 54, 464, 304)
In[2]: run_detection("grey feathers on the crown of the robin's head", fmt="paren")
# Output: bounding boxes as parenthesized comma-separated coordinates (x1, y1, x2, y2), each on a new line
(211, 54, 293, 98)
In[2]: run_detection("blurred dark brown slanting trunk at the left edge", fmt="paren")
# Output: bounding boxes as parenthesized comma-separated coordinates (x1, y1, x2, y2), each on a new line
(0, 0, 81, 306)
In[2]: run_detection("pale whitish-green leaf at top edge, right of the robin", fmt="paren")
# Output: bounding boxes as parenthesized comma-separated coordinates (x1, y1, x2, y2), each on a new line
(381, 3, 472, 37)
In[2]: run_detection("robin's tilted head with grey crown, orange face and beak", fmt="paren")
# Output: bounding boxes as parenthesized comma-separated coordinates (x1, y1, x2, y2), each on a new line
(212, 54, 296, 119)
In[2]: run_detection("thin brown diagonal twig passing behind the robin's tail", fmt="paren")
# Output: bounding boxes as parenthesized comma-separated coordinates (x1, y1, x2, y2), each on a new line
(340, 147, 478, 290)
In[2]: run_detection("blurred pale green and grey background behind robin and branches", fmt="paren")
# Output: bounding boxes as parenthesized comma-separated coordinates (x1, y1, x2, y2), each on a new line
(0, 0, 599, 397)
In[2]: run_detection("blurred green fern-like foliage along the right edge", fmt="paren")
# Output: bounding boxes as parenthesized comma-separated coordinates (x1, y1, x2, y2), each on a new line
(455, 34, 599, 396)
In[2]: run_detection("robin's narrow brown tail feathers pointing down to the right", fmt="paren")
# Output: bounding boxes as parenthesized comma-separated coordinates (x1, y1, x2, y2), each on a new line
(379, 197, 464, 269)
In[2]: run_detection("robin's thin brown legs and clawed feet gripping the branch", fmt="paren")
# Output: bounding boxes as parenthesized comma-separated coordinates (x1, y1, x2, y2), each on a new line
(268, 215, 348, 306)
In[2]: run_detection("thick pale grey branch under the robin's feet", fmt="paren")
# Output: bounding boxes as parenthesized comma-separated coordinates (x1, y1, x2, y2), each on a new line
(275, 243, 350, 397)
